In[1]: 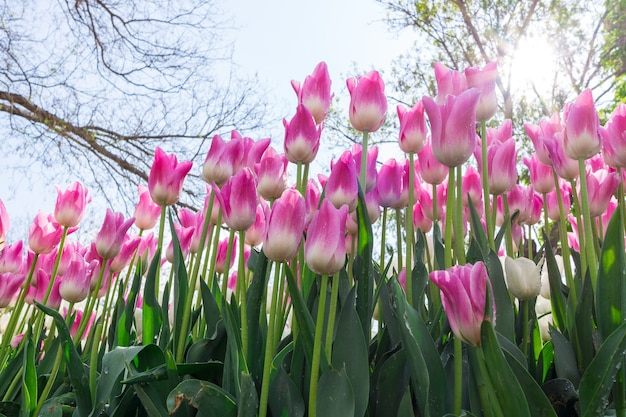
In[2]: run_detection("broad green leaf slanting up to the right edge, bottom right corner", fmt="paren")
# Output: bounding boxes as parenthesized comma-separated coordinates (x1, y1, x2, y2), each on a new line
(578, 322, 626, 417)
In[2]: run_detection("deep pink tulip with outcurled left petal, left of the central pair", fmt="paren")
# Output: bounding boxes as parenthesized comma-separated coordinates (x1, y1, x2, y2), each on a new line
(214, 167, 259, 231)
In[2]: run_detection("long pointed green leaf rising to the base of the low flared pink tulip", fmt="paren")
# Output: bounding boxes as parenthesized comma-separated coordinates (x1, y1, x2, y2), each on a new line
(478, 321, 533, 417)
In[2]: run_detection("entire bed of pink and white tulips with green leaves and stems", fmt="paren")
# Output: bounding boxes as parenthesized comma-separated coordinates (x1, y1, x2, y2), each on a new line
(0, 63, 626, 417)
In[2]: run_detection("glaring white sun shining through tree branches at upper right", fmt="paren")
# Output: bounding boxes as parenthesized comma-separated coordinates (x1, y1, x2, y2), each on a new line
(511, 35, 556, 95)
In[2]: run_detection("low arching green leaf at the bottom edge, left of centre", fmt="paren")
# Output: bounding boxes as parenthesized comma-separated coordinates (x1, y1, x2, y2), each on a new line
(167, 379, 237, 417)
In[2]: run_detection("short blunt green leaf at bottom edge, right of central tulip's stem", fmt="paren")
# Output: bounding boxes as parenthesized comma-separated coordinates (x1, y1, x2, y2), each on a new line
(316, 368, 354, 417)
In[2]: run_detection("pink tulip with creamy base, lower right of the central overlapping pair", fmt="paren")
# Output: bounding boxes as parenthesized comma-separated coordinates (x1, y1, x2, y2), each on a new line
(304, 199, 348, 275)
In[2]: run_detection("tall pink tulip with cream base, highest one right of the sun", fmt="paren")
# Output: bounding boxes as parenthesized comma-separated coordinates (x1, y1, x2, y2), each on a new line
(563, 89, 602, 159)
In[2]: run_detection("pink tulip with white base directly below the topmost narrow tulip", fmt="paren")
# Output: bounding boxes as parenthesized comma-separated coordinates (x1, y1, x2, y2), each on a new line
(283, 104, 322, 164)
